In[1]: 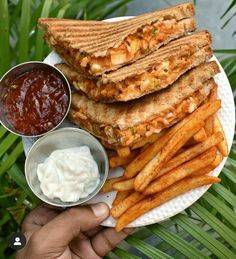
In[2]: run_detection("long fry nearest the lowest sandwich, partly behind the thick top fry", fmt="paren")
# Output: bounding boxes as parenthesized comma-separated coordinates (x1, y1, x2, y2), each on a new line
(124, 100, 221, 181)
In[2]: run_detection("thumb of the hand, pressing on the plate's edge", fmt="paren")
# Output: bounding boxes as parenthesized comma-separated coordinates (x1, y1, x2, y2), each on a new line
(35, 203, 109, 247)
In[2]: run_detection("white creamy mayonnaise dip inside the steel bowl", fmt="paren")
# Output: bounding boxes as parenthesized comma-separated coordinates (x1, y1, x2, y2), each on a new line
(37, 146, 99, 202)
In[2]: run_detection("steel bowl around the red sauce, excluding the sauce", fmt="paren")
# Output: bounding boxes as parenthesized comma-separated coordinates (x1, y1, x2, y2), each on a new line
(0, 61, 71, 137)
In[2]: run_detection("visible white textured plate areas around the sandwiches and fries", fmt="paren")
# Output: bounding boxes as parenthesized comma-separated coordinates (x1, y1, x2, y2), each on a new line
(23, 17, 235, 227)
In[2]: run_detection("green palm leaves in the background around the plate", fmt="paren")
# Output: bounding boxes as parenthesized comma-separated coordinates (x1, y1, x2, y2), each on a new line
(0, 0, 236, 259)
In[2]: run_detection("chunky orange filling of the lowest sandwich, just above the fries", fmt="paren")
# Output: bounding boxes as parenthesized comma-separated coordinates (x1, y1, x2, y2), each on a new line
(70, 89, 208, 146)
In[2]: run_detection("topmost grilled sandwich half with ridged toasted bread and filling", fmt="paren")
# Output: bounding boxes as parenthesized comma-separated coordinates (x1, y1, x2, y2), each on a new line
(38, 3, 196, 75)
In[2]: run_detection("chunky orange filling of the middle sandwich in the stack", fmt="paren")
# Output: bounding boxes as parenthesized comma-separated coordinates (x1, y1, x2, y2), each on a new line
(72, 53, 193, 102)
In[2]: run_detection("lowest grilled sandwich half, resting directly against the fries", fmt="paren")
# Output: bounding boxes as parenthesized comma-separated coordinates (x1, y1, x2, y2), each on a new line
(69, 61, 219, 148)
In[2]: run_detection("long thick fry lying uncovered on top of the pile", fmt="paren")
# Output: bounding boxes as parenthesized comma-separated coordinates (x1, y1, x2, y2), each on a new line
(134, 118, 204, 192)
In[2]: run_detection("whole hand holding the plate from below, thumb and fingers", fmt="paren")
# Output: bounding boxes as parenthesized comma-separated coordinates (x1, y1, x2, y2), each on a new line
(16, 203, 132, 259)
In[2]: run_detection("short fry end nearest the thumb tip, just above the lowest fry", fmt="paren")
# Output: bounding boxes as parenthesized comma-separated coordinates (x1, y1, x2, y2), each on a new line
(111, 192, 144, 218)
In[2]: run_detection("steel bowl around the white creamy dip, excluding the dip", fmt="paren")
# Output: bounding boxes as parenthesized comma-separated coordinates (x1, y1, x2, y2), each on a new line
(25, 127, 109, 207)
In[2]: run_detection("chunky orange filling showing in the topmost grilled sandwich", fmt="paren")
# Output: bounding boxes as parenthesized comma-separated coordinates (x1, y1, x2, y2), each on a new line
(46, 19, 183, 74)
